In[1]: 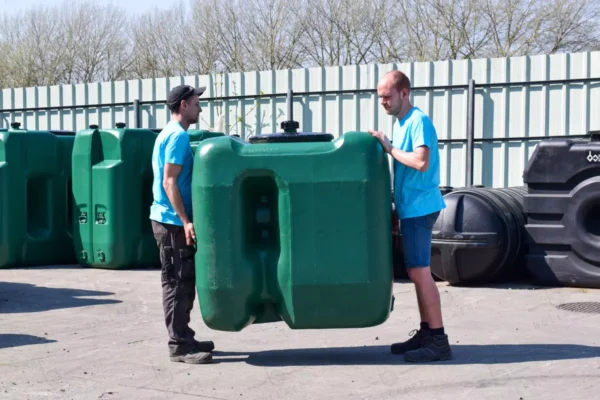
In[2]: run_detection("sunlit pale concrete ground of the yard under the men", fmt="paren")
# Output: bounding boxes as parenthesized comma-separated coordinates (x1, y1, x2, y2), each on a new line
(0, 267, 600, 400)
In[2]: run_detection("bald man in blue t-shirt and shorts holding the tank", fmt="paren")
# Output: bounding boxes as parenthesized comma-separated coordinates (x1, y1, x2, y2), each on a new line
(369, 71, 452, 362)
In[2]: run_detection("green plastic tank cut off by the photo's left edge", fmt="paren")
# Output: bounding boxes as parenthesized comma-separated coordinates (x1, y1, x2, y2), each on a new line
(0, 122, 76, 268)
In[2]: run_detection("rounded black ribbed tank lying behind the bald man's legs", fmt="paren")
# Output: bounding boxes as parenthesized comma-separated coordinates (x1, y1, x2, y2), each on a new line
(431, 186, 527, 285)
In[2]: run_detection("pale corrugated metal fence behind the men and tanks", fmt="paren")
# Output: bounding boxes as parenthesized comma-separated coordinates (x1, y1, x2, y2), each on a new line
(0, 52, 600, 187)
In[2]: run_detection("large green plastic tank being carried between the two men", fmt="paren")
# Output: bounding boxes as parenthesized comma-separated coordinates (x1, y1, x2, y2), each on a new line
(192, 90, 393, 331)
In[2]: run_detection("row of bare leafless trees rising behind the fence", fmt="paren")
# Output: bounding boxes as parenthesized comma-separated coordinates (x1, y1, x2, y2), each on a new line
(0, 0, 600, 87)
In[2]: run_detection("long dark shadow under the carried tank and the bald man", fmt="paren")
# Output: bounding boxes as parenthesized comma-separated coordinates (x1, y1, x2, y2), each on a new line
(213, 344, 600, 367)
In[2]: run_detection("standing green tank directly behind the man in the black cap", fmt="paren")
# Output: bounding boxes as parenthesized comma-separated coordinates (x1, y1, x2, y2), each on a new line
(72, 123, 222, 269)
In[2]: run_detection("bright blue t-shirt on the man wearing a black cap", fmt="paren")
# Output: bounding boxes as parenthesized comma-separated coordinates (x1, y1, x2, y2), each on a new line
(150, 121, 194, 226)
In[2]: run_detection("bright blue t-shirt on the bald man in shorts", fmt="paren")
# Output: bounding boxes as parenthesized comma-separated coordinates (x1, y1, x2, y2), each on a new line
(392, 107, 446, 219)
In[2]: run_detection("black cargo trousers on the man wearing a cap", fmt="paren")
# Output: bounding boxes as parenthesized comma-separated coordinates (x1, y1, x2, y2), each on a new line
(152, 220, 196, 355)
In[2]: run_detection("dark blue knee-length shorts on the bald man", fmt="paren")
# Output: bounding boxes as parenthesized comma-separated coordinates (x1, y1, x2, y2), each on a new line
(400, 211, 440, 268)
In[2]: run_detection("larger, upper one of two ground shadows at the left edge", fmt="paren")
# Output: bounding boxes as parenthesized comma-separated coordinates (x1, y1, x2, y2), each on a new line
(0, 282, 121, 314)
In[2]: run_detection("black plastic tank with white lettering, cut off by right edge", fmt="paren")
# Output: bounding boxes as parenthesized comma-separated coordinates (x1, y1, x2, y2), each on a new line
(523, 131, 600, 288)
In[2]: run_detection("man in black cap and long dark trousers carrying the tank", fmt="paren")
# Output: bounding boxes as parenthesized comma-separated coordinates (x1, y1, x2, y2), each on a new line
(150, 85, 215, 364)
